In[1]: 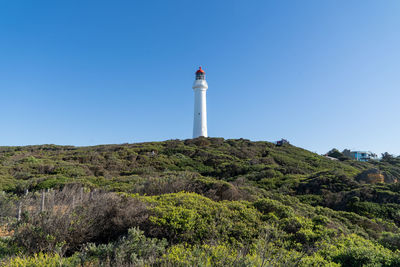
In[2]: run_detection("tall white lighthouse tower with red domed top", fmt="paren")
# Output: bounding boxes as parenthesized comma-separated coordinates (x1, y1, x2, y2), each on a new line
(192, 67, 208, 138)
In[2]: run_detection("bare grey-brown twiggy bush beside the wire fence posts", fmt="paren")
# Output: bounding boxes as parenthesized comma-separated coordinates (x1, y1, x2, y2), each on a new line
(14, 188, 148, 253)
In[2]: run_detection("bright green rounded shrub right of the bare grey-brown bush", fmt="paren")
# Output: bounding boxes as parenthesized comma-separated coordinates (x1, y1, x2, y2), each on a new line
(147, 192, 261, 247)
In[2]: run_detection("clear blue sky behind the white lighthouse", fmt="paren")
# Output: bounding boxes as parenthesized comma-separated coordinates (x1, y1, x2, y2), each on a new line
(0, 0, 400, 154)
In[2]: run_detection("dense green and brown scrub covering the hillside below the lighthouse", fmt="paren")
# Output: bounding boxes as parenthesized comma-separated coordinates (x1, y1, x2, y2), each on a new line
(0, 138, 400, 266)
